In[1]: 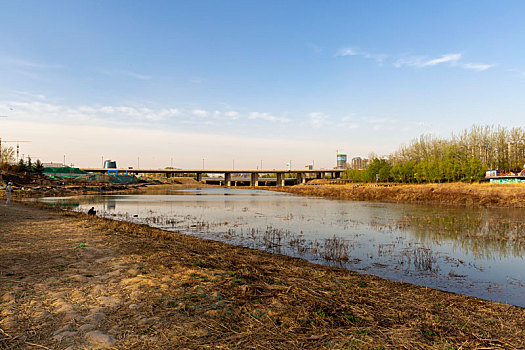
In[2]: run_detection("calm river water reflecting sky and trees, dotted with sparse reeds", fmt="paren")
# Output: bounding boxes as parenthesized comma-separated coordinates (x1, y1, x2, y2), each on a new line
(41, 188, 525, 307)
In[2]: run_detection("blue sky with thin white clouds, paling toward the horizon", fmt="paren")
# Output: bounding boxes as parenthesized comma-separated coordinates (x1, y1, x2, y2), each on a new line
(0, 0, 525, 169)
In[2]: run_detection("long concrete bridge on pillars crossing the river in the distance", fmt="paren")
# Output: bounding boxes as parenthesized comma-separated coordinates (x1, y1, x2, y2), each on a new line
(80, 168, 343, 187)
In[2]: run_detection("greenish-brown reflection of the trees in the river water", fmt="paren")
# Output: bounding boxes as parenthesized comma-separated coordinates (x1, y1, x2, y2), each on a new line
(380, 208, 525, 259)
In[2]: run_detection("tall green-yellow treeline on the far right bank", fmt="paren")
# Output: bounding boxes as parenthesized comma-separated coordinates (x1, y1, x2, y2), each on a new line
(346, 126, 525, 183)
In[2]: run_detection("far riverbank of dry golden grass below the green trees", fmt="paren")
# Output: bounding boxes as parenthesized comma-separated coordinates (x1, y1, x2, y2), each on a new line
(272, 180, 525, 208)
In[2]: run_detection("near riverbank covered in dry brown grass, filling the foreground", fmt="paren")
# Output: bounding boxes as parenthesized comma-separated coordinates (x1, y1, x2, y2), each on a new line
(0, 203, 525, 349)
